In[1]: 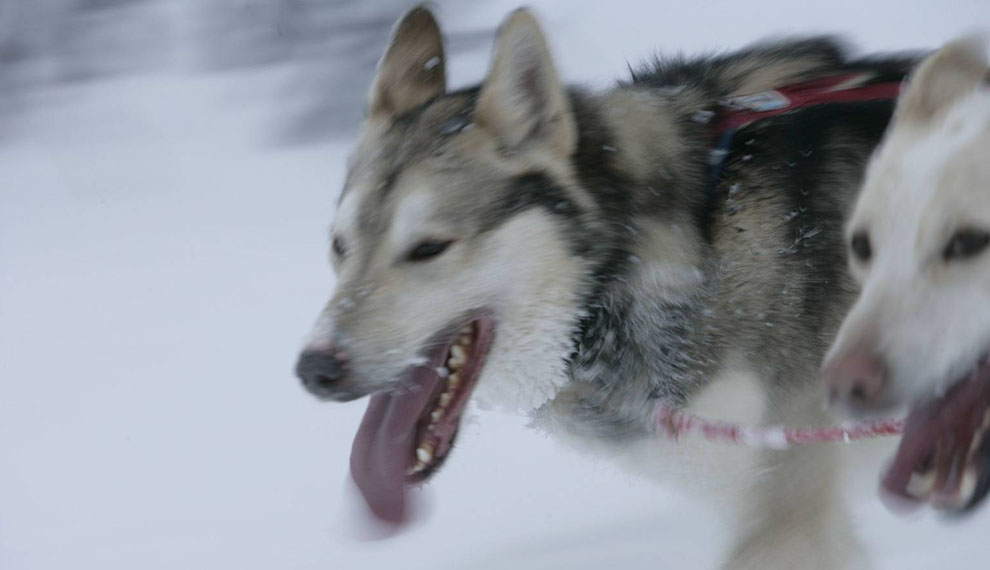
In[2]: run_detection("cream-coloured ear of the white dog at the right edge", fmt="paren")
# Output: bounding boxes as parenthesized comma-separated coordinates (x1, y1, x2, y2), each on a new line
(897, 35, 990, 121)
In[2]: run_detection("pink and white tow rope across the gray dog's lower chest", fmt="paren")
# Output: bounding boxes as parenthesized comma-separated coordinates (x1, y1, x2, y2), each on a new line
(654, 404, 904, 449)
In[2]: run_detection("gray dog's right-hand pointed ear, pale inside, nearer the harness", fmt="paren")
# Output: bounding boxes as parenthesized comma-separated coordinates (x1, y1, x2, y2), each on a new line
(475, 9, 577, 156)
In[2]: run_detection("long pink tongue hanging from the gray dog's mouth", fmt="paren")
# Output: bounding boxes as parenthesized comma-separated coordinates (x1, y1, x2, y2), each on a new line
(351, 368, 440, 523)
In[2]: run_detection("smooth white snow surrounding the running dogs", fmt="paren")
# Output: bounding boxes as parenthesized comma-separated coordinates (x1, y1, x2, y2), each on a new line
(0, 0, 990, 570)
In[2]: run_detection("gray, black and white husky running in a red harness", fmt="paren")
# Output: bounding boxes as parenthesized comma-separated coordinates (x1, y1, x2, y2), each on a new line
(297, 8, 911, 570)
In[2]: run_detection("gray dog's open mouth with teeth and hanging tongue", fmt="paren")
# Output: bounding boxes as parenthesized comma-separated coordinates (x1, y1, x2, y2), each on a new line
(351, 315, 495, 523)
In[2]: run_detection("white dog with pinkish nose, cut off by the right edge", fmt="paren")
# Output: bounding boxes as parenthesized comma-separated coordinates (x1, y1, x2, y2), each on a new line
(824, 37, 990, 510)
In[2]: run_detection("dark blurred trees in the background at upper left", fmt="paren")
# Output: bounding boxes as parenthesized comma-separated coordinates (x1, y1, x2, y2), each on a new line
(0, 0, 490, 141)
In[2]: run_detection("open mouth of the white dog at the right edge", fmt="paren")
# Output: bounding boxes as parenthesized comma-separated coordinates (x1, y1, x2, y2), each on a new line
(882, 357, 990, 510)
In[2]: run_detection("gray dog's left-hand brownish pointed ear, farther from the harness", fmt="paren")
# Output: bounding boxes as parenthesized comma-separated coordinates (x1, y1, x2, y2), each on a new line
(368, 6, 447, 119)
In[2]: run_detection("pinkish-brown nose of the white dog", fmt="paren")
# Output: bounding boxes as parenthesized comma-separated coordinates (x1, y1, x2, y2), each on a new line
(822, 352, 887, 409)
